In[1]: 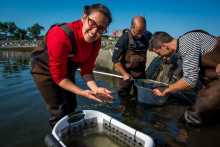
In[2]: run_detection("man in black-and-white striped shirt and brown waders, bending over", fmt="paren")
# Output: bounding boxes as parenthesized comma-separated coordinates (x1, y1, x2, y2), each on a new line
(149, 30, 220, 126)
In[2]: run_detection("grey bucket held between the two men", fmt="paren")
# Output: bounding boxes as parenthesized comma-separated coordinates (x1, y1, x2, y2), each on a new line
(134, 79, 170, 106)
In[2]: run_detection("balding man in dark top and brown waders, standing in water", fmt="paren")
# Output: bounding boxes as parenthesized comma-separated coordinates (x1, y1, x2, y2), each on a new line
(112, 16, 152, 97)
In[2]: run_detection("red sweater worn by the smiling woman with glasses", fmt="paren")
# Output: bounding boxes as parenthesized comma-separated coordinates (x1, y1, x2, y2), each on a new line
(47, 20, 101, 85)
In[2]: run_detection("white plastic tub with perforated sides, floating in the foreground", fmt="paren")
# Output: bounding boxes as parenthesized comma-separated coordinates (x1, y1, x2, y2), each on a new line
(45, 110, 156, 147)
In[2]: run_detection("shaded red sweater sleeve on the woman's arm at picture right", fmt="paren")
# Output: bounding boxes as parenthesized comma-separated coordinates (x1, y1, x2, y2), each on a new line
(80, 38, 101, 77)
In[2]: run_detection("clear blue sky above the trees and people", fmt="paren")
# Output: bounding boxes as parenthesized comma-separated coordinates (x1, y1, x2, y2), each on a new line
(0, 0, 220, 38)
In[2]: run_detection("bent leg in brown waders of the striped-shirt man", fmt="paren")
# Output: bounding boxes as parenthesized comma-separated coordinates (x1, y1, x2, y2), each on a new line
(180, 79, 220, 126)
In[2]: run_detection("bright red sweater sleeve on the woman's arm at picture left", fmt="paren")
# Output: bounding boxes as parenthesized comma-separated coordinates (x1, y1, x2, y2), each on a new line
(47, 27, 70, 85)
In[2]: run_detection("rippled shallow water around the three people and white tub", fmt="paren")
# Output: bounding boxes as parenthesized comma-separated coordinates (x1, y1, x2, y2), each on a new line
(0, 50, 220, 147)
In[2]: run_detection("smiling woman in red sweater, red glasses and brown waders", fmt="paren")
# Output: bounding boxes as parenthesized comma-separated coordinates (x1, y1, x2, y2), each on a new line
(31, 4, 112, 127)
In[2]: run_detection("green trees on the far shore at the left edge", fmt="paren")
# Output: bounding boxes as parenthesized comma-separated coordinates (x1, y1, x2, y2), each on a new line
(0, 22, 44, 40)
